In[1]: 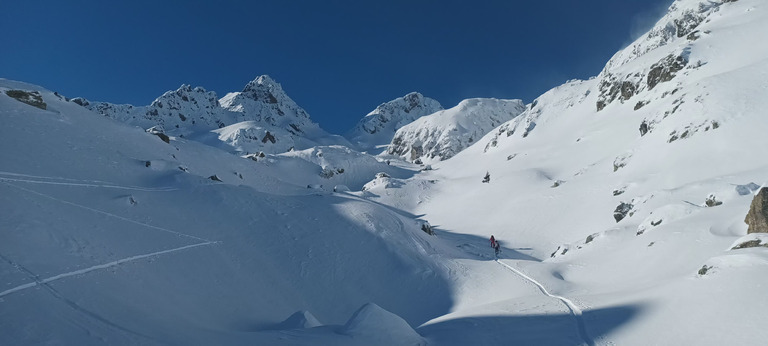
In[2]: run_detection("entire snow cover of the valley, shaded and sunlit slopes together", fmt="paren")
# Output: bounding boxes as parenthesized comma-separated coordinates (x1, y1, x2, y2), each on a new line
(0, 0, 768, 345)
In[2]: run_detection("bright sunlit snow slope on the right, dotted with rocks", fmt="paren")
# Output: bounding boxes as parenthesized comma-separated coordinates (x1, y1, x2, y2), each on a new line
(360, 1, 768, 345)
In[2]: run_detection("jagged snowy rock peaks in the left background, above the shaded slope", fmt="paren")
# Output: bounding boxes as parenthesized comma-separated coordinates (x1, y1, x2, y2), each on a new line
(78, 75, 350, 153)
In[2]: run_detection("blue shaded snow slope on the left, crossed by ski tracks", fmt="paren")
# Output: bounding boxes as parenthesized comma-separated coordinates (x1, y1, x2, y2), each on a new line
(0, 81, 450, 344)
